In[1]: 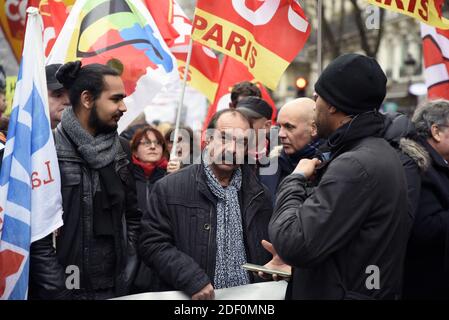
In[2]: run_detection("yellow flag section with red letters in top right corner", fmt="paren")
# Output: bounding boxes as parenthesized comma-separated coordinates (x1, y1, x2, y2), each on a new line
(367, 0, 449, 29)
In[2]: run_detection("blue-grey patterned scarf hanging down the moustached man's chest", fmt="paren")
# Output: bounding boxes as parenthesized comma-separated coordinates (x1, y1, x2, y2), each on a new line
(203, 162, 250, 289)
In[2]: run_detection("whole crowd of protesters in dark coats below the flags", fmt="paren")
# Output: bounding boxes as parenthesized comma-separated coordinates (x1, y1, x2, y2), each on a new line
(19, 54, 449, 300)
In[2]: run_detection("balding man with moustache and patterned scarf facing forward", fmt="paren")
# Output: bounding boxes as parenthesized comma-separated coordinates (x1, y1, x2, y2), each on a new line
(139, 109, 272, 300)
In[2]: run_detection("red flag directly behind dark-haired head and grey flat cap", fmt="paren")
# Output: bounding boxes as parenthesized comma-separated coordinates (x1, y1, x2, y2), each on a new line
(203, 56, 277, 129)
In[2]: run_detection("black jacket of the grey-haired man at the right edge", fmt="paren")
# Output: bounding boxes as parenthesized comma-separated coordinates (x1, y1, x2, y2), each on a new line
(404, 140, 449, 299)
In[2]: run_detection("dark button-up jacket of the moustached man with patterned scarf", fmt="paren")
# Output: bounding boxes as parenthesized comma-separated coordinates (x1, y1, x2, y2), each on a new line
(139, 165, 272, 295)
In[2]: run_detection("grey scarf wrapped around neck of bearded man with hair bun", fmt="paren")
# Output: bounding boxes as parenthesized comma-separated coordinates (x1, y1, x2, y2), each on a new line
(61, 107, 120, 169)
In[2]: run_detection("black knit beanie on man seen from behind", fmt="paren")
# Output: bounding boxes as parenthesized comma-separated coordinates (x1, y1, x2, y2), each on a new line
(315, 53, 387, 115)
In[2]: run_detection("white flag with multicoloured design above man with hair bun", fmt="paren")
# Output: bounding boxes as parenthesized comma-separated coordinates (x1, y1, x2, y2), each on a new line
(47, 0, 179, 131)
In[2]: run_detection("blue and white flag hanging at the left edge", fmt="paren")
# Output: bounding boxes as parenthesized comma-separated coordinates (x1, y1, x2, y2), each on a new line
(0, 8, 62, 300)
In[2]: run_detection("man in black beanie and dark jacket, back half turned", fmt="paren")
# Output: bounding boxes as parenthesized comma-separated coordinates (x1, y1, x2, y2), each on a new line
(268, 54, 408, 299)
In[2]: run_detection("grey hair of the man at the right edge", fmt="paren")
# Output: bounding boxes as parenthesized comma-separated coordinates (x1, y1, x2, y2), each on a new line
(412, 99, 449, 139)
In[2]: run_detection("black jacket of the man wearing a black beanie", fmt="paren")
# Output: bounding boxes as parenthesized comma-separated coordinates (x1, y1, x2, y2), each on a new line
(269, 114, 408, 299)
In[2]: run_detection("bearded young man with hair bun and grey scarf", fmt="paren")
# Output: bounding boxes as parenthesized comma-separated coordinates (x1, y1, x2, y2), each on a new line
(29, 61, 141, 299)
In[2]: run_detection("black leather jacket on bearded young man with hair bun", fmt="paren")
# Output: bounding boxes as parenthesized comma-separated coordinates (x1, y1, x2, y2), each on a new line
(29, 125, 141, 299)
